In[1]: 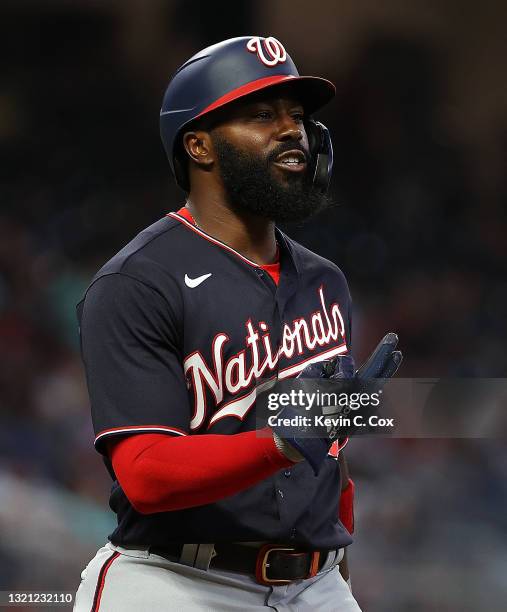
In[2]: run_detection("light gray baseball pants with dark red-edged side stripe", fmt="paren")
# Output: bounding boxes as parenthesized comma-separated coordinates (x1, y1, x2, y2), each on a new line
(74, 542, 361, 612)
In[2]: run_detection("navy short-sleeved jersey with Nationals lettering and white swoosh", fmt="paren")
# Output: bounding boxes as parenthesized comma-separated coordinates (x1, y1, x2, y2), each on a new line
(78, 213, 352, 549)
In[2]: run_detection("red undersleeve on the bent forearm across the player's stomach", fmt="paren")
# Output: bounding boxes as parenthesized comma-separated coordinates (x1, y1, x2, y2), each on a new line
(108, 429, 294, 514)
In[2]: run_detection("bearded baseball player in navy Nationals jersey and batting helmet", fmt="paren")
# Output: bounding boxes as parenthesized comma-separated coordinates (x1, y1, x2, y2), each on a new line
(74, 36, 400, 612)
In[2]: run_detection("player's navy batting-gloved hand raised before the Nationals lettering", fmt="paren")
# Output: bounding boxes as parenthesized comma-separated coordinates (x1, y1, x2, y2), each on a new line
(272, 332, 403, 475)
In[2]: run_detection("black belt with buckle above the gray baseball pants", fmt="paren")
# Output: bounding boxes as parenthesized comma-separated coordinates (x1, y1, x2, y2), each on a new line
(150, 542, 338, 585)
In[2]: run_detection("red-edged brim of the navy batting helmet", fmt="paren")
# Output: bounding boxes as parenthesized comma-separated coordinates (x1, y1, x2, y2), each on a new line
(196, 75, 336, 118)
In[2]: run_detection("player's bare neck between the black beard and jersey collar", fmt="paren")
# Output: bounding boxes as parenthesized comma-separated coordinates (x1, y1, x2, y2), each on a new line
(187, 190, 276, 264)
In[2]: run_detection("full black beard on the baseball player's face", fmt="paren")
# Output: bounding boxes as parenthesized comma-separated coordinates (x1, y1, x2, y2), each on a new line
(213, 134, 329, 223)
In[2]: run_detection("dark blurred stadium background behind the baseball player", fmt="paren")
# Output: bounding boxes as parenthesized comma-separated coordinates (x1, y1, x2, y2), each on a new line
(0, 0, 507, 612)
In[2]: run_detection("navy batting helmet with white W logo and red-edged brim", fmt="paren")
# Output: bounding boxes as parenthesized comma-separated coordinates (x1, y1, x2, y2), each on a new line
(160, 36, 336, 192)
